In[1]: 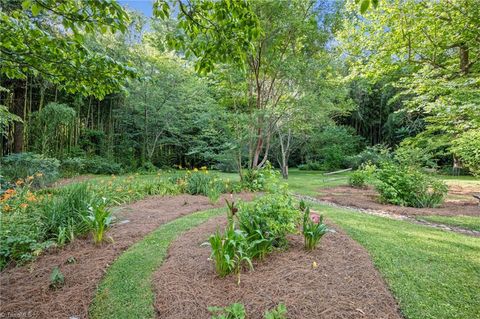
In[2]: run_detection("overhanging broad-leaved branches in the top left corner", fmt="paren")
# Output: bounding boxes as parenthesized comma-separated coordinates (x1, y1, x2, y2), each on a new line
(0, 0, 134, 98)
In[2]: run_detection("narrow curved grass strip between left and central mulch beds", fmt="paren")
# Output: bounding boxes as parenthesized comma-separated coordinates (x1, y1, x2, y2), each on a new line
(89, 209, 225, 319)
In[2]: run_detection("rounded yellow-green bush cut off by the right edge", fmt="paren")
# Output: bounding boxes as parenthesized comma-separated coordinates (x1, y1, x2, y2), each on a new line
(452, 129, 480, 176)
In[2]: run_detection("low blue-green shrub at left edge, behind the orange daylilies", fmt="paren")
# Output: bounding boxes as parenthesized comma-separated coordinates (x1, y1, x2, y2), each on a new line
(0, 153, 60, 187)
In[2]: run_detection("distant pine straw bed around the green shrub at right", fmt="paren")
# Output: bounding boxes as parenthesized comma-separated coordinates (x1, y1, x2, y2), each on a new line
(316, 186, 480, 216)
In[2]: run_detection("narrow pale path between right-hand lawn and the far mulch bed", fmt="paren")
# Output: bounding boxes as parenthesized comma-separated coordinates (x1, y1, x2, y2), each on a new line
(295, 195, 480, 237)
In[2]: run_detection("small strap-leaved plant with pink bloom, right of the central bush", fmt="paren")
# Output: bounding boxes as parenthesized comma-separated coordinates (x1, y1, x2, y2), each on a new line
(300, 201, 328, 250)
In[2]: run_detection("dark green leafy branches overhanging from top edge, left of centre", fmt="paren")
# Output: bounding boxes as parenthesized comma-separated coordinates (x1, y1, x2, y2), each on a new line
(153, 0, 261, 73)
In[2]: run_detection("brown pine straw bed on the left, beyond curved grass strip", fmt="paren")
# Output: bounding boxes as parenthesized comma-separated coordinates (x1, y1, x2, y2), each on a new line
(0, 194, 253, 319)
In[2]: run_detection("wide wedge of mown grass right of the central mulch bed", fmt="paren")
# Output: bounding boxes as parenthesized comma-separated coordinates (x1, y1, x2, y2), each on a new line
(314, 205, 480, 319)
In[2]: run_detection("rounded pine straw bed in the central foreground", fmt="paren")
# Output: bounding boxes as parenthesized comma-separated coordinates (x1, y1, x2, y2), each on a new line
(153, 217, 402, 319)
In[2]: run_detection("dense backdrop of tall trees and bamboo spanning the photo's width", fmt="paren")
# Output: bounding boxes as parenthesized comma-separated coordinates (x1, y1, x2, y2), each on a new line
(0, 0, 480, 177)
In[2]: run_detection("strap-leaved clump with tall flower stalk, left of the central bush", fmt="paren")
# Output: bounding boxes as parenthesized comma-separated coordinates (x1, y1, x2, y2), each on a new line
(208, 202, 253, 284)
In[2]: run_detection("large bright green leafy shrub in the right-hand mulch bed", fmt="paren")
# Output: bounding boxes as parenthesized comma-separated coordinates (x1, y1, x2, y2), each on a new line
(375, 163, 448, 207)
